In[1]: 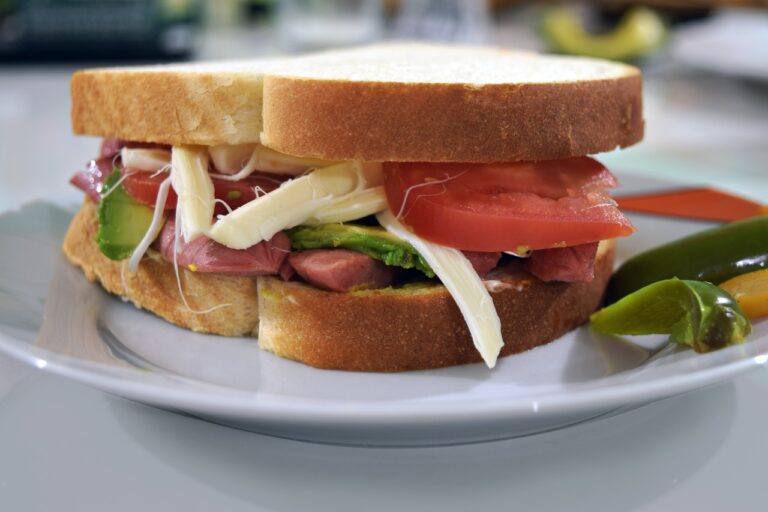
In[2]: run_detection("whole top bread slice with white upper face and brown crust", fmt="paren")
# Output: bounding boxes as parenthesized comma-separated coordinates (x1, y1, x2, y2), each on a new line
(72, 44, 643, 162)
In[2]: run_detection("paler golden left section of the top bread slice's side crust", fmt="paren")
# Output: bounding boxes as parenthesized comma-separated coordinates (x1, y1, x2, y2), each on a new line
(71, 68, 262, 145)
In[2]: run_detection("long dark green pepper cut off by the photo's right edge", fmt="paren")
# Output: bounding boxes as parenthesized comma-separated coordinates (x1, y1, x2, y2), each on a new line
(608, 215, 768, 302)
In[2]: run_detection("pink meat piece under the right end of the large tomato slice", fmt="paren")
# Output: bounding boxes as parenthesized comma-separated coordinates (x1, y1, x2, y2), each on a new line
(525, 242, 597, 283)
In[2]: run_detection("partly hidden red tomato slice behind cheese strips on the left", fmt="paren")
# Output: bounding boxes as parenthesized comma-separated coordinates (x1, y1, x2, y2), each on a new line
(122, 169, 287, 213)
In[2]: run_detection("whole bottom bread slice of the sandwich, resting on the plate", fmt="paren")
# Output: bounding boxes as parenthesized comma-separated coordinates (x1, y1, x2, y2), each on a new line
(63, 200, 614, 372)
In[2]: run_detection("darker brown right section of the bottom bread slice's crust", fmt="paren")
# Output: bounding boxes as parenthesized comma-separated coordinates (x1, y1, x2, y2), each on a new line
(259, 242, 614, 372)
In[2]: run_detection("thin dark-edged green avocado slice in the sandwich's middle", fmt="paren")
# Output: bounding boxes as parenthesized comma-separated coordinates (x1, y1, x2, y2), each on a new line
(286, 224, 435, 277)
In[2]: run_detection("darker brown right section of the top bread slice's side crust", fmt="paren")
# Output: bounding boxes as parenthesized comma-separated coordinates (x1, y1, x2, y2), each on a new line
(263, 73, 644, 162)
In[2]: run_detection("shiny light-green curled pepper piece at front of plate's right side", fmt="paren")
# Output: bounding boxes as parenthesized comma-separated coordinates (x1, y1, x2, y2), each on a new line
(591, 278, 752, 352)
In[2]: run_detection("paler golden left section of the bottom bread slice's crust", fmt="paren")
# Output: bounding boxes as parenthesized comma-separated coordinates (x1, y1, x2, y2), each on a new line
(63, 199, 259, 336)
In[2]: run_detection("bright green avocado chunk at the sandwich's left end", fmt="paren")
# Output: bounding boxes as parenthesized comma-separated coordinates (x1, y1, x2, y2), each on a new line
(96, 170, 153, 260)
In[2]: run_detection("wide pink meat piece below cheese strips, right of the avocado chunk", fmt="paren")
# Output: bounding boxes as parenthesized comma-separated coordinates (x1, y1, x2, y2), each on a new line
(154, 218, 291, 276)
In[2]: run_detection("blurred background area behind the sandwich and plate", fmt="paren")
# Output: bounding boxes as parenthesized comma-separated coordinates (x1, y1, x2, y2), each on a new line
(0, 0, 768, 209)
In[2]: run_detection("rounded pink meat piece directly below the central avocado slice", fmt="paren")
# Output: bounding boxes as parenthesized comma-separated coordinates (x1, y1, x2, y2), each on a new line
(288, 249, 396, 292)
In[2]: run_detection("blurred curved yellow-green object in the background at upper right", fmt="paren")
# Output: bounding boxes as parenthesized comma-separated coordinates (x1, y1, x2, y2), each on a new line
(541, 7, 667, 61)
